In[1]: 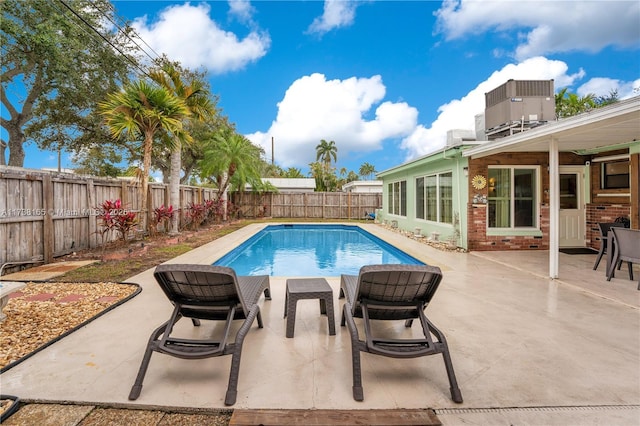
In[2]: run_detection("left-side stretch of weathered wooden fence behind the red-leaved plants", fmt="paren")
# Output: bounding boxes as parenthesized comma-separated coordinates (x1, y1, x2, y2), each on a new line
(0, 166, 216, 265)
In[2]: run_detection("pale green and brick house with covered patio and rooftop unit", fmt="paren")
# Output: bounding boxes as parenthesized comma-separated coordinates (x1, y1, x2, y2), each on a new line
(378, 80, 640, 278)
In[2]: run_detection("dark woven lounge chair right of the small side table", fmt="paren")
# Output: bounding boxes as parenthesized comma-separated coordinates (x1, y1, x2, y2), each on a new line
(340, 264, 462, 402)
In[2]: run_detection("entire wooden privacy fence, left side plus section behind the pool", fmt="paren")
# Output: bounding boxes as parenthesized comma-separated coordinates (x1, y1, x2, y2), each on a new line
(0, 166, 382, 274)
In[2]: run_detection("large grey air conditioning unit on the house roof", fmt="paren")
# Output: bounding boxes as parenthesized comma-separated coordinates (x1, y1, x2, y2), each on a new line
(485, 80, 556, 140)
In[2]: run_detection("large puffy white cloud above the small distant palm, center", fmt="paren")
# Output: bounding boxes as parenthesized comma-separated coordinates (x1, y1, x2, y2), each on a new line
(246, 74, 418, 168)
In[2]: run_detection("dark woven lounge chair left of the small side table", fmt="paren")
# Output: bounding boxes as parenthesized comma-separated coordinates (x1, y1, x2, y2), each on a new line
(129, 264, 271, 405)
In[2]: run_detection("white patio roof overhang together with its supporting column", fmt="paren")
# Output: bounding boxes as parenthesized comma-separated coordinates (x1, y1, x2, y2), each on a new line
(462, 96, 640, 278)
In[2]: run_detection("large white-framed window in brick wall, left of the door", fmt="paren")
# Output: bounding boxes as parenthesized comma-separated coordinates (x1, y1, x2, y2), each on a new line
(487, 167, 539, 228)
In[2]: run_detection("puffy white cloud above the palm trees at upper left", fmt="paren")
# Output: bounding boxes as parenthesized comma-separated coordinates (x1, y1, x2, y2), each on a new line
(132, 2, 271, 74)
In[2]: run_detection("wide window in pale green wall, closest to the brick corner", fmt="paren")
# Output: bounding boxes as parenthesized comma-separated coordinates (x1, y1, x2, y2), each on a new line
(416, 172, 453, 223)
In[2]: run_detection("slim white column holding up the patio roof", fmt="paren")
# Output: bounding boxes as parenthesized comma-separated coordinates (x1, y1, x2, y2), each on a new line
(549, 136, 560, 278)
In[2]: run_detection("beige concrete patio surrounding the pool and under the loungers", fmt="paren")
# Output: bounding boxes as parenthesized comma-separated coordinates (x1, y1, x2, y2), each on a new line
(0, 224, 640, 425)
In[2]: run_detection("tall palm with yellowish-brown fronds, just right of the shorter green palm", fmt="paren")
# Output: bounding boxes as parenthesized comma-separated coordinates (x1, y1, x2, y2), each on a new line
(150, 62, 214, 234)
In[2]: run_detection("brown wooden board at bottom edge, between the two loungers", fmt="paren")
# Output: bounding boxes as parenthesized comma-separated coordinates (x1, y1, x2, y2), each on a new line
(229, 409, 442, 426)
